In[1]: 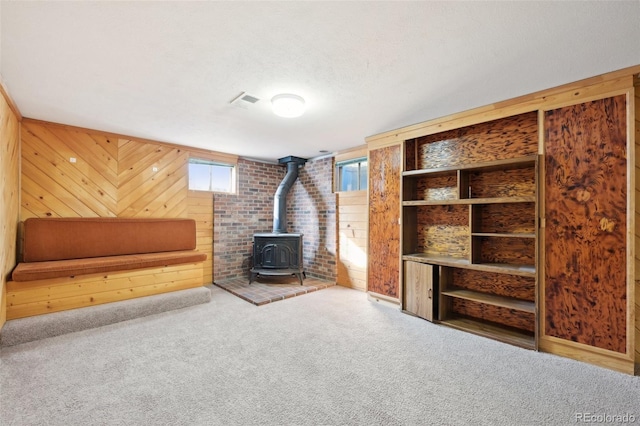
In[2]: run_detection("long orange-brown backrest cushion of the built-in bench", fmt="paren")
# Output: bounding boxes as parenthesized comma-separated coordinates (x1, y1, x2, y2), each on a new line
(22, 218, 196, 262)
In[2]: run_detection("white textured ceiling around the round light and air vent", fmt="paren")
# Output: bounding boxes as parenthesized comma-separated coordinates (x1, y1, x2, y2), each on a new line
(0, 0, 640, 160)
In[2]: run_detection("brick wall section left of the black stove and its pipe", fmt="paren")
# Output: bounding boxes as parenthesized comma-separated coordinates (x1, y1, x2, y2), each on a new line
(213, 159, 285, 281)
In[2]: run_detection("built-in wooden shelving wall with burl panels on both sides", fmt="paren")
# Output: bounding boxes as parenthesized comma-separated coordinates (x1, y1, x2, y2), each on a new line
(367, 65, 640, 374)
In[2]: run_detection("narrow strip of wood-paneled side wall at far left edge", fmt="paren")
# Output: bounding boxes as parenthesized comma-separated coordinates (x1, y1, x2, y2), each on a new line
(0, 85, 20, 328)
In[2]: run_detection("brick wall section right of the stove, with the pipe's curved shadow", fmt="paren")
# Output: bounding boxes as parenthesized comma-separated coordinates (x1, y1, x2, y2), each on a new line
(287, 158, 337, 281)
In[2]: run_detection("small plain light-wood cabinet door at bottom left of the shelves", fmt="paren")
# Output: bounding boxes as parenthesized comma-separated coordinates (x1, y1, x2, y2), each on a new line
(404, 261, 438, 321)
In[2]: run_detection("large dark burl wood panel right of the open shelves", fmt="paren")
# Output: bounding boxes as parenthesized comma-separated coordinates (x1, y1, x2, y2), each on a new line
(544, 95, 627, 353)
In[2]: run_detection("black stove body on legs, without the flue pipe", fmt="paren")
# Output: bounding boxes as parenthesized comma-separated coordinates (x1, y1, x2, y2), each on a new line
(249, 233, 306, 285)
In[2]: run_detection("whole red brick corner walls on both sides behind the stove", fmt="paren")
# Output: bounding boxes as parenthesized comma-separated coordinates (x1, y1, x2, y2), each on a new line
(213, 158, 337, 281)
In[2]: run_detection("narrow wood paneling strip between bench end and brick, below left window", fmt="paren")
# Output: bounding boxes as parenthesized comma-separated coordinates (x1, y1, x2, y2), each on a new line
(187, 191, 213, 284)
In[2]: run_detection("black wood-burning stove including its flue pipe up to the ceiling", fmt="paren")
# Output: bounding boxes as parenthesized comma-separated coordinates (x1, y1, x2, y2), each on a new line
(249, 156, 307, 285)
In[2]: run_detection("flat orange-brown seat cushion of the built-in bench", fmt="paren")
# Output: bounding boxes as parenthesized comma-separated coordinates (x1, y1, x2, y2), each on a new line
(11, 250, 207, 281)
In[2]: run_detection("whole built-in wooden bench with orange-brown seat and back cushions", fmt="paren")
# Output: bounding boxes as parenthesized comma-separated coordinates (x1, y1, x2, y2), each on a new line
(6, 218, 207, 320)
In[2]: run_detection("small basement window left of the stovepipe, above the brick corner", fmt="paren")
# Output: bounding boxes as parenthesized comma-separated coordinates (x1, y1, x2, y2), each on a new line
(189, 158, 236, 194)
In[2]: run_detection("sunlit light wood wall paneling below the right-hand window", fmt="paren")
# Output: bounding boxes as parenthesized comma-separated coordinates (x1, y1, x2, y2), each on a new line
(337, 191, 368, 291)
